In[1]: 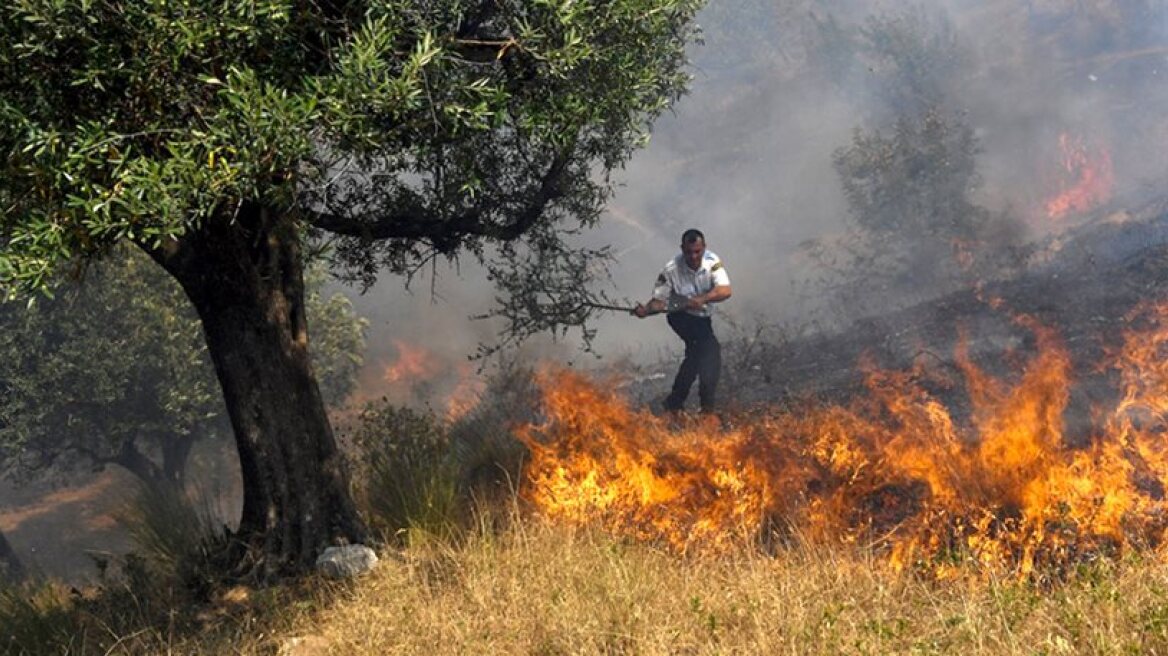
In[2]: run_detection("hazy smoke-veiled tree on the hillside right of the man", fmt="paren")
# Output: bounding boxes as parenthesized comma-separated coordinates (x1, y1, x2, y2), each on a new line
(805, 111, 1022, 314)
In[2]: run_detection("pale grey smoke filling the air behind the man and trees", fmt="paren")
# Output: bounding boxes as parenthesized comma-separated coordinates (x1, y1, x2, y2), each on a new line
(329, 0, 1168, 389)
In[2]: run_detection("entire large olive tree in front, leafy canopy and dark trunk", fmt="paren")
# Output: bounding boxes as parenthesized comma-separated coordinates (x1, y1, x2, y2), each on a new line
(0, 0, 701, 575)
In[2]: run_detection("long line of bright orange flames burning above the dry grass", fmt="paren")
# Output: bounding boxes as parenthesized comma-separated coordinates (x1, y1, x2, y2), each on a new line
(520, 303, 1168, 578)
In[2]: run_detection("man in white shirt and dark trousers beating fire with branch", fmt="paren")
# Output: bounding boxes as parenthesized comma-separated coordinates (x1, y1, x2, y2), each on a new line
(633, 229, 730, 413)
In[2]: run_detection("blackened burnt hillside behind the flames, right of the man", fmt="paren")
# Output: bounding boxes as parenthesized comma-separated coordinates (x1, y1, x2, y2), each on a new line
(631, 200, 1168, 434)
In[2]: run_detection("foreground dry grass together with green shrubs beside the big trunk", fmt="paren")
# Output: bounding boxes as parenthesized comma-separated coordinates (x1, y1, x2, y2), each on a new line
(0, 269, 1168, 656)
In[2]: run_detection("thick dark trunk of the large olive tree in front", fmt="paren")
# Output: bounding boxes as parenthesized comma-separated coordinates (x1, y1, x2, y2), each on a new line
(144, 204, 366, 579)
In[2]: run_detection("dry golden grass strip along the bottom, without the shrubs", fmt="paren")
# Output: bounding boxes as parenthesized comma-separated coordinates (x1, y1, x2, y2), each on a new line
(6, 508, 1168, 656)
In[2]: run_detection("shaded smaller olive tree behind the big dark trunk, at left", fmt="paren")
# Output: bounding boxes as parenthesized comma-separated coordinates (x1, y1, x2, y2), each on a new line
(0, 249, 367, 483)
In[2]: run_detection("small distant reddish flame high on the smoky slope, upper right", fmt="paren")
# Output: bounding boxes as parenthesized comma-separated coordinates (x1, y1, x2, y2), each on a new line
(1045, 132, 1115, 219)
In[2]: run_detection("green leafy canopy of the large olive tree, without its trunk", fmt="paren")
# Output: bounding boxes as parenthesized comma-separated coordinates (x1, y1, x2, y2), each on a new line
(0, 0, 701, 350)
